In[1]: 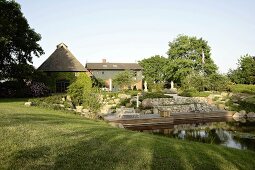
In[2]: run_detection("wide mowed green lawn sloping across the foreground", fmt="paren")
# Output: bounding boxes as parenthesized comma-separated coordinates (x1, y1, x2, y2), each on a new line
(0, 99, 255, 170)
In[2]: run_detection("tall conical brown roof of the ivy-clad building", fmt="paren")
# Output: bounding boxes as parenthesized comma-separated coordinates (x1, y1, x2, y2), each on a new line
(38, 43, 87, 72)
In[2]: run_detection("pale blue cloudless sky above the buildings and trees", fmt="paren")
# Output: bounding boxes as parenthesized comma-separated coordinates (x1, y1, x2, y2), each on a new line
(17, 0, 255, 73)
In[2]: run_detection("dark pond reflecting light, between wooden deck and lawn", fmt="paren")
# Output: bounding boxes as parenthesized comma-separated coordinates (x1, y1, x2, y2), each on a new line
(144, 120, 255, 151)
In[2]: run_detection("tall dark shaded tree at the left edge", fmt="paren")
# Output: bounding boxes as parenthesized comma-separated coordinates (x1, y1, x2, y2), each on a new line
(0, 0, 43, 78)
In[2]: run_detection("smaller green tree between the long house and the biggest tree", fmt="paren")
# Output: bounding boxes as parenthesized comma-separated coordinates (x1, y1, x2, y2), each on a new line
(139, 55, 167, 83)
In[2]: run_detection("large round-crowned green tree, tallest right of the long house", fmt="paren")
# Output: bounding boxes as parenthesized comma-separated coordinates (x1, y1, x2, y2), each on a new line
(167, 35, 218, 79)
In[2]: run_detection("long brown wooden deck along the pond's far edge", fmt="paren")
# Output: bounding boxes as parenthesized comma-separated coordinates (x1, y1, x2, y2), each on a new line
(105, 111, 233, 130)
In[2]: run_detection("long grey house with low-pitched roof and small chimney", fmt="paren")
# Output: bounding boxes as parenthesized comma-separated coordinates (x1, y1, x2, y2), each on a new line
(86, 59, 143, 91)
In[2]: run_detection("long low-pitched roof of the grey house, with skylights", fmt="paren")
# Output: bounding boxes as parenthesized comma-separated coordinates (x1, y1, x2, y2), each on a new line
(86, 63, 143, 70)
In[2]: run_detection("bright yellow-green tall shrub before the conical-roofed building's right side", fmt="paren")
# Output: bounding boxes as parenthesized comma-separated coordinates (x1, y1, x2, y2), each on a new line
(67, 73, 92, 105)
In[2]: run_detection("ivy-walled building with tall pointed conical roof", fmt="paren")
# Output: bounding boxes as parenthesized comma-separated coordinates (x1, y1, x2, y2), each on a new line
(38, 43, 90, 93)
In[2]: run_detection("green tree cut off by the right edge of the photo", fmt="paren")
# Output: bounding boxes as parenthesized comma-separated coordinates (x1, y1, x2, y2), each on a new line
(228, 54, 255, 84)
